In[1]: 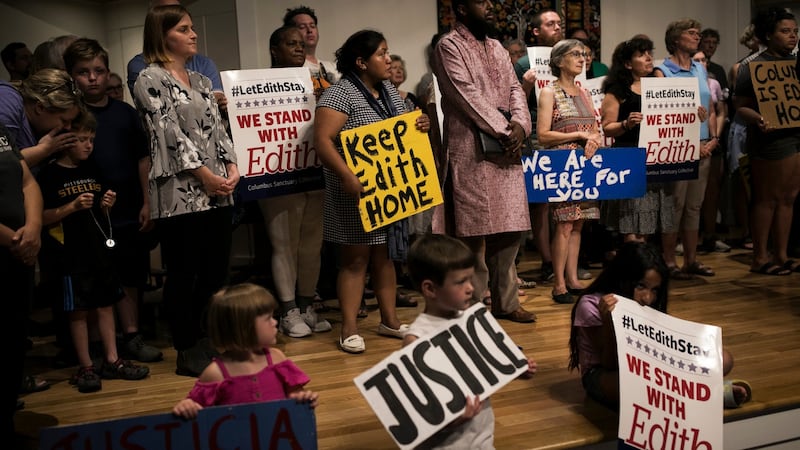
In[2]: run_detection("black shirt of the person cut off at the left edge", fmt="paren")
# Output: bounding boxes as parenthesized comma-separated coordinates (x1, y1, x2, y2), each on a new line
(0, 124, 25, 230)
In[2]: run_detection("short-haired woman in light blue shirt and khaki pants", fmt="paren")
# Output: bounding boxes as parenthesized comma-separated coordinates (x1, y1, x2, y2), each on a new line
(654, 19, 719, 280)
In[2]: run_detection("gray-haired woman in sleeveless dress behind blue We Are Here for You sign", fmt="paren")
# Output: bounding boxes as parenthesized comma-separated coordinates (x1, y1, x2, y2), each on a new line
(536, 39, 602, 303)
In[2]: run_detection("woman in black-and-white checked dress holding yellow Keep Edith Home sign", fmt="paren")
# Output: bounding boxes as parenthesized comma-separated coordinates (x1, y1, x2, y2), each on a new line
(314, 30, 430, 353)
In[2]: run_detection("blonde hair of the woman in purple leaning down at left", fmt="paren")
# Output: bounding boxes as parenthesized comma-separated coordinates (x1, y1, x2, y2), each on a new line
(17, 69, 83, 111)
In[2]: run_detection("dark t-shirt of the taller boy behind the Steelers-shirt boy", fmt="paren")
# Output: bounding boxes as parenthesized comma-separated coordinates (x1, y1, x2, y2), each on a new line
(88, 98, 150, 225)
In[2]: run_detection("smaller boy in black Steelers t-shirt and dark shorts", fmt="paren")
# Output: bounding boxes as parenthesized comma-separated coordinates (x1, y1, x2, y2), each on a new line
(37, 114, 150, 392)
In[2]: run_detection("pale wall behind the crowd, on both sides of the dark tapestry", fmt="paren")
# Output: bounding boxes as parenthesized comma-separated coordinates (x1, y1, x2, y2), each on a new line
(0, 0, 764, 86)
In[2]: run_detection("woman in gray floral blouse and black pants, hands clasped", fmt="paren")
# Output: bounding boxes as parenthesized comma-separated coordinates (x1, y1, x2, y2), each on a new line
(134, 5, 239, 376)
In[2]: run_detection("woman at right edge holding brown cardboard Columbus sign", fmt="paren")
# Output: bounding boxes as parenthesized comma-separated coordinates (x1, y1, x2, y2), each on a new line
(734, 8, 800, 275)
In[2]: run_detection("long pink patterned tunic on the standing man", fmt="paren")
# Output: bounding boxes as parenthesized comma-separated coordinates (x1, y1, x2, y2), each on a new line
(433, 23, 531, 237)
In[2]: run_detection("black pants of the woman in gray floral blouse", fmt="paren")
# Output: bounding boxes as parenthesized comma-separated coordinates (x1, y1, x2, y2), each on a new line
(157, 207, 232, 350)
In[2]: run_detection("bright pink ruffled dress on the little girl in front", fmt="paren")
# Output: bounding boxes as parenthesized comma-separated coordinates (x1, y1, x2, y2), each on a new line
(189, 348, 310, 407)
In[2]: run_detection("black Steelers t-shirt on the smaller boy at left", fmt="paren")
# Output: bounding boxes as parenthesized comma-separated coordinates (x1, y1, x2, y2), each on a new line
(37, 161, 111, 275)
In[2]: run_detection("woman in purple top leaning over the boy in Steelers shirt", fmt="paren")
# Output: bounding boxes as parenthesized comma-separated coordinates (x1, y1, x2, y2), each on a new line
(0, 69, 84, 167)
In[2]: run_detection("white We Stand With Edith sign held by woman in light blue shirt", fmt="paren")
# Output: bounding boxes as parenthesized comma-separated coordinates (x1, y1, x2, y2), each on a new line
(639, 77, 700, 182)
